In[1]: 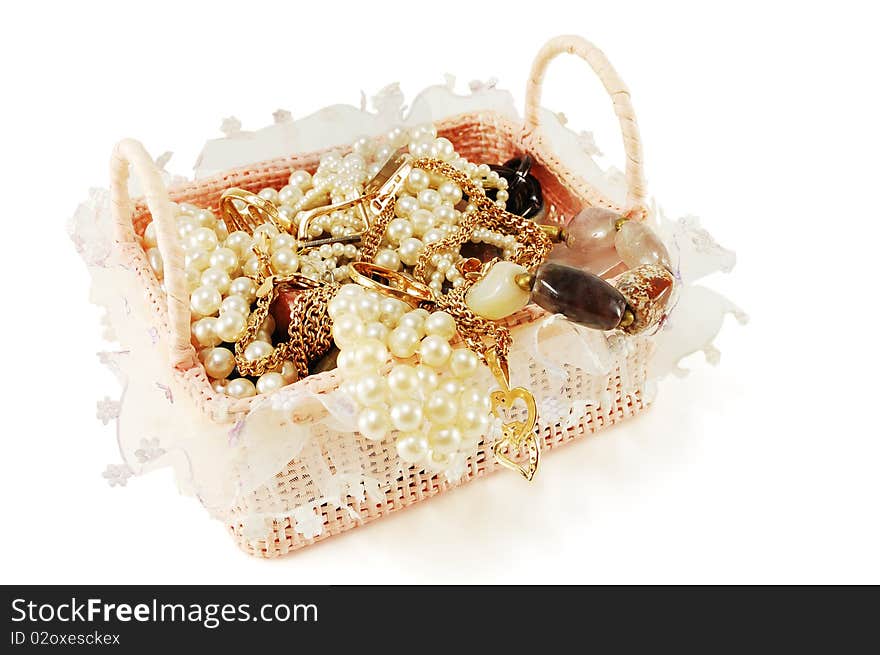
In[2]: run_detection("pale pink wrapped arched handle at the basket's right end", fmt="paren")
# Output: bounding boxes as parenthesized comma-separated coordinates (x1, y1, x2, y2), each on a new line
(525, 35, 645, 209)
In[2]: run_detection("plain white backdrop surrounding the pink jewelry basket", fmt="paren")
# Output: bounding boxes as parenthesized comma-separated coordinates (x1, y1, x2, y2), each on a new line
(0, 0, 880, 583)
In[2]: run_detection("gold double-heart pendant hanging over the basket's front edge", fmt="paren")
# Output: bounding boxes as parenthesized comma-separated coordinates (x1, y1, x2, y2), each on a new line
(486, 348, 541, 482)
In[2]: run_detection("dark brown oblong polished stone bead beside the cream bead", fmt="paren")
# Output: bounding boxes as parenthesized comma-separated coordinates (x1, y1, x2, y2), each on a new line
(532, 262, 626, 330)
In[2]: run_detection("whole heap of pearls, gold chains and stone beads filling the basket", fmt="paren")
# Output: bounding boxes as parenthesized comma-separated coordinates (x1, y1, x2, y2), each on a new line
(142, 126, 673, 479)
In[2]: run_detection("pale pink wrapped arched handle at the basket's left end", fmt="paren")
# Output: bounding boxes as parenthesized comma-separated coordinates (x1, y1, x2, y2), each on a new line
(110, 139, 196, 370)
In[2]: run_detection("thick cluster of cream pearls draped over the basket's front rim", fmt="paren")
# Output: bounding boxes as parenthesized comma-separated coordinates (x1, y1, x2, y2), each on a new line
(327, 284, 491, 471)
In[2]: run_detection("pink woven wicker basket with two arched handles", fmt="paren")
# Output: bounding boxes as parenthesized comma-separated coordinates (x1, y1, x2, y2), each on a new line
(111, 36, 653, 557)
